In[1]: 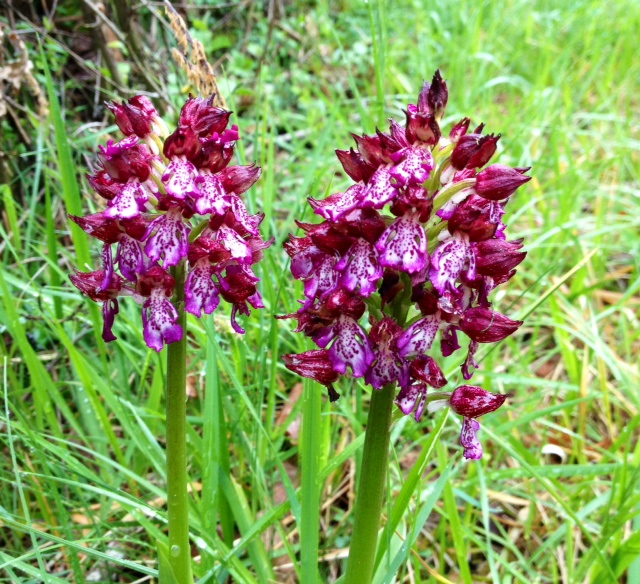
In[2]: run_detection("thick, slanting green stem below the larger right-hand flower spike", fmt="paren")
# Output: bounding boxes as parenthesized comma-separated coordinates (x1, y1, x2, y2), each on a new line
(344, 384, 395, 584)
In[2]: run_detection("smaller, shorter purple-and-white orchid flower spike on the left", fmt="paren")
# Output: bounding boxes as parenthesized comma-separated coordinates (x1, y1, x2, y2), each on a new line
(71, 96, 271, 351)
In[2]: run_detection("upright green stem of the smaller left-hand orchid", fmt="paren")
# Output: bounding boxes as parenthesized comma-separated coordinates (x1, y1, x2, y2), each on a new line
(167, 262, 193, 584)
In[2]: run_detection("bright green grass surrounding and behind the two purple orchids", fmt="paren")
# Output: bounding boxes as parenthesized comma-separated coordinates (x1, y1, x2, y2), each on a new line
(0, 0, 640, 584)
